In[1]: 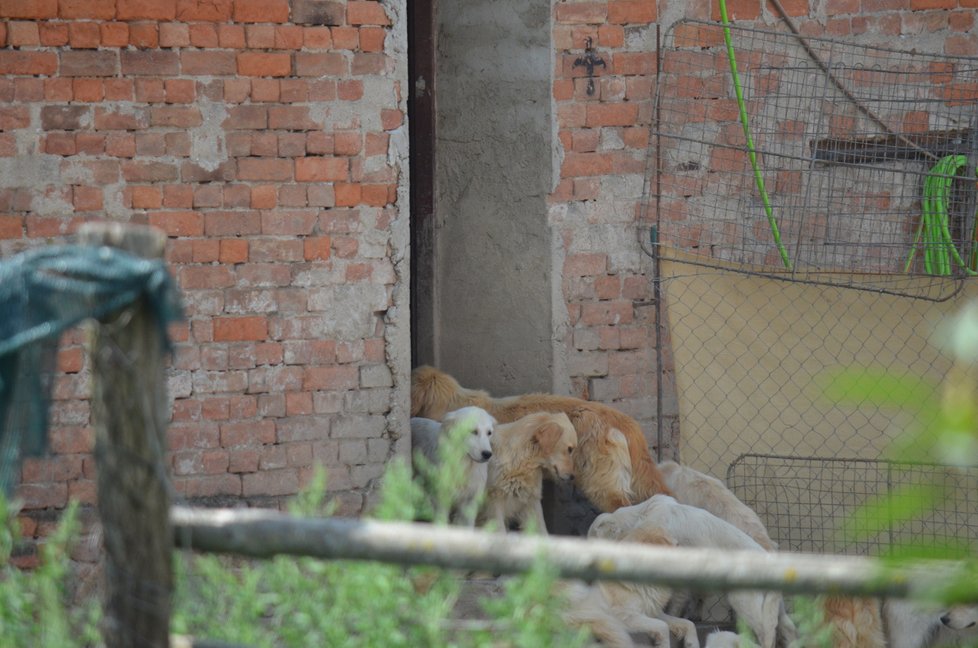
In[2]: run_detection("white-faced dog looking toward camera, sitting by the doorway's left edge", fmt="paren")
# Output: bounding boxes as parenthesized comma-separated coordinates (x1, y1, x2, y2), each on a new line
(411, 407, 496, 527)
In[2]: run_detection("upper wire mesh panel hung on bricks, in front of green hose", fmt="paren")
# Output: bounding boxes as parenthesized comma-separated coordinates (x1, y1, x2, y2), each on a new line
(650, 21, 978, 299)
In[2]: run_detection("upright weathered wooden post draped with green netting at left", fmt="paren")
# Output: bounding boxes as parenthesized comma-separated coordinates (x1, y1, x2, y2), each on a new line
(79, 223, 173, 648)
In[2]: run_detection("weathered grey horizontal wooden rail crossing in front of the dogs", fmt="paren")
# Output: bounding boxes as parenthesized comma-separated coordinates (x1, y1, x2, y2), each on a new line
(170, 506, 960, 598)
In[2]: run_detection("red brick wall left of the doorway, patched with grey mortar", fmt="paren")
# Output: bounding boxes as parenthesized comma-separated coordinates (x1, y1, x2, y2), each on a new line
(0, 0, 409, 548)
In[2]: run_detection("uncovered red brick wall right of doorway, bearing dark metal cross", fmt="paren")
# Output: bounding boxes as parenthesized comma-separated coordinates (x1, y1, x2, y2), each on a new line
(550, 0, 978, 458)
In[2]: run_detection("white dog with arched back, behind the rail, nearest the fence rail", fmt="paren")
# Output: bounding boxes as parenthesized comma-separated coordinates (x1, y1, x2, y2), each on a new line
(588, 495, 794, 648)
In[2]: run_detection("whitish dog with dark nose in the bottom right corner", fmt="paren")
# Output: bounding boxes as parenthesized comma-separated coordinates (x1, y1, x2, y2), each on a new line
(883, 599, 978, 648)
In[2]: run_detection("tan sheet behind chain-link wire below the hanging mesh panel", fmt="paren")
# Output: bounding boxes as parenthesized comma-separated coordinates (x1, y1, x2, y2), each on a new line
(661, 253, 978, 479)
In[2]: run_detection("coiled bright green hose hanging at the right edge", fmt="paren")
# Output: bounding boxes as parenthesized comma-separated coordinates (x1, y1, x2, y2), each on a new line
(904, 155, 978, 275)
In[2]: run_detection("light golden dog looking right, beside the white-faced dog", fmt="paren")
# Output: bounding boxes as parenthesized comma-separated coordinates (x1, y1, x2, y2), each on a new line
(479, 412, 577, 534)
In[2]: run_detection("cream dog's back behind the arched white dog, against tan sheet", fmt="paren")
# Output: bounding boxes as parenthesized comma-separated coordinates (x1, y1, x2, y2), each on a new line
(659, 461, 778, 551)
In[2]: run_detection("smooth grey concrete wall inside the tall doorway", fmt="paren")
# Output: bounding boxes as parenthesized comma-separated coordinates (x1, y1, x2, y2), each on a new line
(434, 0, 559, 394)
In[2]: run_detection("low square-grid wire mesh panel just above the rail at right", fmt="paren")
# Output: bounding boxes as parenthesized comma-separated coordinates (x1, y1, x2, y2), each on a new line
(726, 454, 978, 555)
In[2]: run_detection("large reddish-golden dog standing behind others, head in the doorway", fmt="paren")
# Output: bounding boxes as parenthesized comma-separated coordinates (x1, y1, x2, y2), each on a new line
(411, 366, 671, 511)
